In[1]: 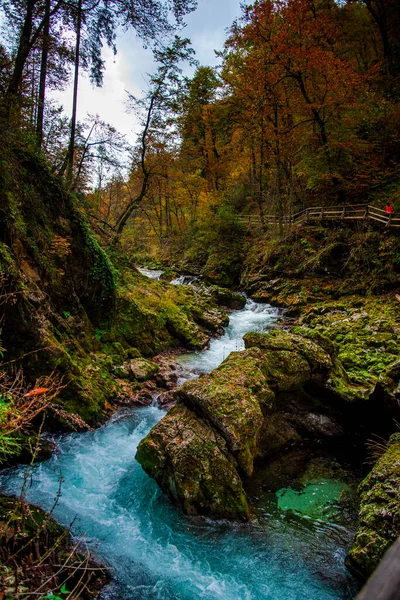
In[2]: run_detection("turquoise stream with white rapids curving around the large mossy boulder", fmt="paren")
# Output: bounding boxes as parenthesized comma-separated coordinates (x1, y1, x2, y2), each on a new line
(0, 301, 356, 600)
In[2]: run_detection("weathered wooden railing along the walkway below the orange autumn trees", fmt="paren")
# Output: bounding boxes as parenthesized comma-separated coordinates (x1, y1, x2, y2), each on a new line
(238, 204, 400, 227)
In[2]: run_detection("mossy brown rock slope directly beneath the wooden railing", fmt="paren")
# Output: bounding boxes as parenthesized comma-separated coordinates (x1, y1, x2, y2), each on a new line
(241, 223, 400, 302)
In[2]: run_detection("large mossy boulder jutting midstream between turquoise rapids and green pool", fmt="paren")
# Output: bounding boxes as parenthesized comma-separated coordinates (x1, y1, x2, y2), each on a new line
(137, 331, 343, 518)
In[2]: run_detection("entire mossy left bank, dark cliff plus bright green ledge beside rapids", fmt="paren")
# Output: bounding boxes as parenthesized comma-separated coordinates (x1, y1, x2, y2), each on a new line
(0, 134, 227, 427)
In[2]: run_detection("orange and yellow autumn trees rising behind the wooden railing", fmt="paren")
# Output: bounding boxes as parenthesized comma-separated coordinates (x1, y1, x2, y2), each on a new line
(83, 0, 400, 264)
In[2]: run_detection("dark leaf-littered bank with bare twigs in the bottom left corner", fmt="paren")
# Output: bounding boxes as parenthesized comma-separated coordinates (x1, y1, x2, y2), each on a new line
(0, 494, 110, 600)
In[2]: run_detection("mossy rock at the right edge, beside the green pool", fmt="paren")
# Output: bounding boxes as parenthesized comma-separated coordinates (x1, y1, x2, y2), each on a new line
(346, 433, 400, 579)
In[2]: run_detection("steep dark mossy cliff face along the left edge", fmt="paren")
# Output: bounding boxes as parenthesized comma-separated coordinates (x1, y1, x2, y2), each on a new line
(0, 130, 122, 423)
